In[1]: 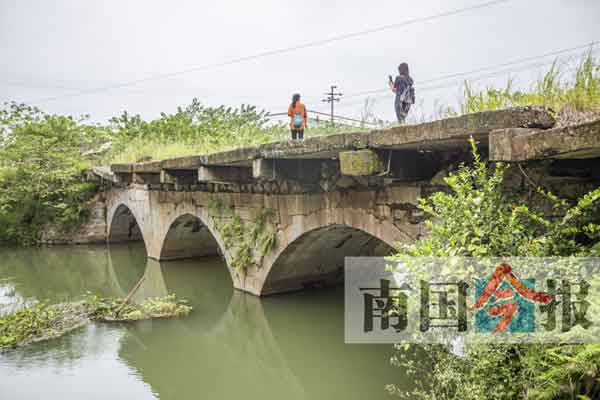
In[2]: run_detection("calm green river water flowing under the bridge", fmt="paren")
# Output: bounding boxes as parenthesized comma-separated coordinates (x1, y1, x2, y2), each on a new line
(0, 245, 407, 400)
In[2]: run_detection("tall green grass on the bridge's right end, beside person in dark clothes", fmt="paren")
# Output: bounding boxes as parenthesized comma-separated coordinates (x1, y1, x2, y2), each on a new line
(460, 50, 600, 113)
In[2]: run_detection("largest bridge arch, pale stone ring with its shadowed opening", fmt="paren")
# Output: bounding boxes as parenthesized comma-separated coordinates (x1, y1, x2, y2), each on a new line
(258, 209, 413, 295)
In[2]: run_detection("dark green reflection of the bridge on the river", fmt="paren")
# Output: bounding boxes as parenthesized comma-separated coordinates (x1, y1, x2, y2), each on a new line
(108, 247, 401, 399)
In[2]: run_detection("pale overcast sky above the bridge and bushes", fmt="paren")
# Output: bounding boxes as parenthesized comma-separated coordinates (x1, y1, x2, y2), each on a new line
(0, 0, 600, 122)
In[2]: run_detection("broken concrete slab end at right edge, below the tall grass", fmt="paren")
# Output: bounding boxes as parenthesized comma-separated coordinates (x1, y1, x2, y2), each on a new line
(489, 119, 600, 162)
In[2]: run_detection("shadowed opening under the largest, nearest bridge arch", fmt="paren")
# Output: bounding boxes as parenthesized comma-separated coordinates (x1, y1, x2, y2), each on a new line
(261, 225, 393, 295)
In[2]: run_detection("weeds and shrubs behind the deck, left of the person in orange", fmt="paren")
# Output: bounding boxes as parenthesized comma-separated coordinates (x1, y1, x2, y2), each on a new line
(104, 99, 351, 163)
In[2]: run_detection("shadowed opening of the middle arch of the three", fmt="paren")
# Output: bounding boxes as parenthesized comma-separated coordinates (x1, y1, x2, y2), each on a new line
(160, 214, 221, 260)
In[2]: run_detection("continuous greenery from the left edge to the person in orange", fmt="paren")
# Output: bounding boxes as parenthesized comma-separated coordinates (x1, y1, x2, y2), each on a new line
(0, 99, 349, 245)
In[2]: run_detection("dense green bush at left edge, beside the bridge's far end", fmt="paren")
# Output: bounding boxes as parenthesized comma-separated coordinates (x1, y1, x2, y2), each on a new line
(0, 104, 106, 244)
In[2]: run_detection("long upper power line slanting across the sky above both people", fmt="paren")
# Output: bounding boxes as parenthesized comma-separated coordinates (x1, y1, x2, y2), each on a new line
(24, 0, 512, 103)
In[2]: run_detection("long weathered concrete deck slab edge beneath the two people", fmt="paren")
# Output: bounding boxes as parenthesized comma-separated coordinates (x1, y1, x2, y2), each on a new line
(104, 107, 556, 173)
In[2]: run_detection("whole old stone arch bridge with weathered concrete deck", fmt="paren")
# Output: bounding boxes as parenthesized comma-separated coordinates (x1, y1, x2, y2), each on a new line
(96, 107, 600, 295)
